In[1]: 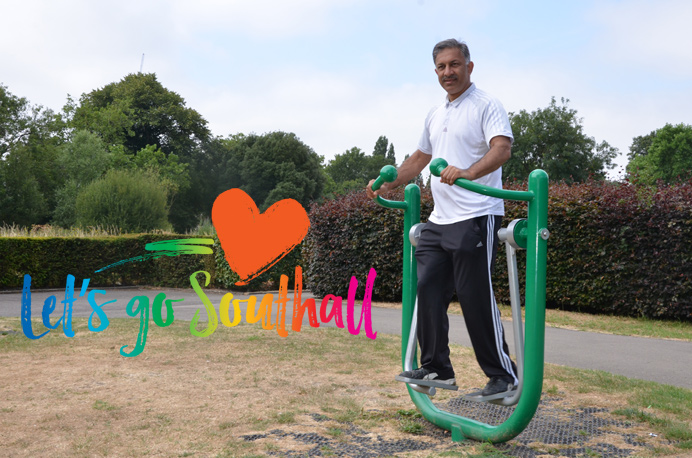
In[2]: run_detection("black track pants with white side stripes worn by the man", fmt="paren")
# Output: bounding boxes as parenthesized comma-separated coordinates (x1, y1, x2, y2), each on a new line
(416, 215, 516, 382)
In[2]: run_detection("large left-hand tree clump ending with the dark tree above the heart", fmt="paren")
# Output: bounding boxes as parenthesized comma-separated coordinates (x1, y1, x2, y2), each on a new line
(0, 77, 326, 232)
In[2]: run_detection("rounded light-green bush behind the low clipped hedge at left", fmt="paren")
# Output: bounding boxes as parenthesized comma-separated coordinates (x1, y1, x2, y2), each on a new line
(76, 169, 170, 232)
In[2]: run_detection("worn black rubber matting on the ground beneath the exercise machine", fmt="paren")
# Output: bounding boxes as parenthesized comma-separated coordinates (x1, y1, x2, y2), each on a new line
(242, 397, 660, 458)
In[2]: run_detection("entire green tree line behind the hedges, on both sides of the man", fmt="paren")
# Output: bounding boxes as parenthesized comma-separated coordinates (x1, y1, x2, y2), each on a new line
(0, 77, 692, 231)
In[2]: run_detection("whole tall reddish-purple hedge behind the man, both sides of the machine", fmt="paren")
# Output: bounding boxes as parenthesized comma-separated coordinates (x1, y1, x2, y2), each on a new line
(303, 181, 692, 321)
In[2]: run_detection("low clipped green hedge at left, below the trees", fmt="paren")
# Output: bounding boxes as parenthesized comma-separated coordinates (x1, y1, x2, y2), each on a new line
(0, 234, 216, 289)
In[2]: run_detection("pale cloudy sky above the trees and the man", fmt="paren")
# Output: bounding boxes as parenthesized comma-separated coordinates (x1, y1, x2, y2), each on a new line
(0, 0, 692, 178)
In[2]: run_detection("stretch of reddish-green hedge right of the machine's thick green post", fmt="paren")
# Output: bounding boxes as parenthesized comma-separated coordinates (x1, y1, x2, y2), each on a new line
(536, 182, 692, 321)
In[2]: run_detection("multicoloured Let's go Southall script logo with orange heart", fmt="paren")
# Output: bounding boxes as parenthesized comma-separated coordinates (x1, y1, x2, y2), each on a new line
(21, 189, 377, 357)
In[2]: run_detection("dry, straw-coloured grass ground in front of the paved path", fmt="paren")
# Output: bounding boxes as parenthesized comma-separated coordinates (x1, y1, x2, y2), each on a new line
(0, 318, 680, 457)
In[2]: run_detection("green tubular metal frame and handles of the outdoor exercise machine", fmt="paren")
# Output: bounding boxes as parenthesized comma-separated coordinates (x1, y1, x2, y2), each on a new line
(372, 159, 549, 442)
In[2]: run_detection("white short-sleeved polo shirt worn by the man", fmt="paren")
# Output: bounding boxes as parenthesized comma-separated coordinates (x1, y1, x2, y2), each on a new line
(418, 84, 514, 224)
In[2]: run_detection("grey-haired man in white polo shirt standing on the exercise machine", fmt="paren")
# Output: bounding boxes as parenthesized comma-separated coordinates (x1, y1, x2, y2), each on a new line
(367, 39, 517, 396)
